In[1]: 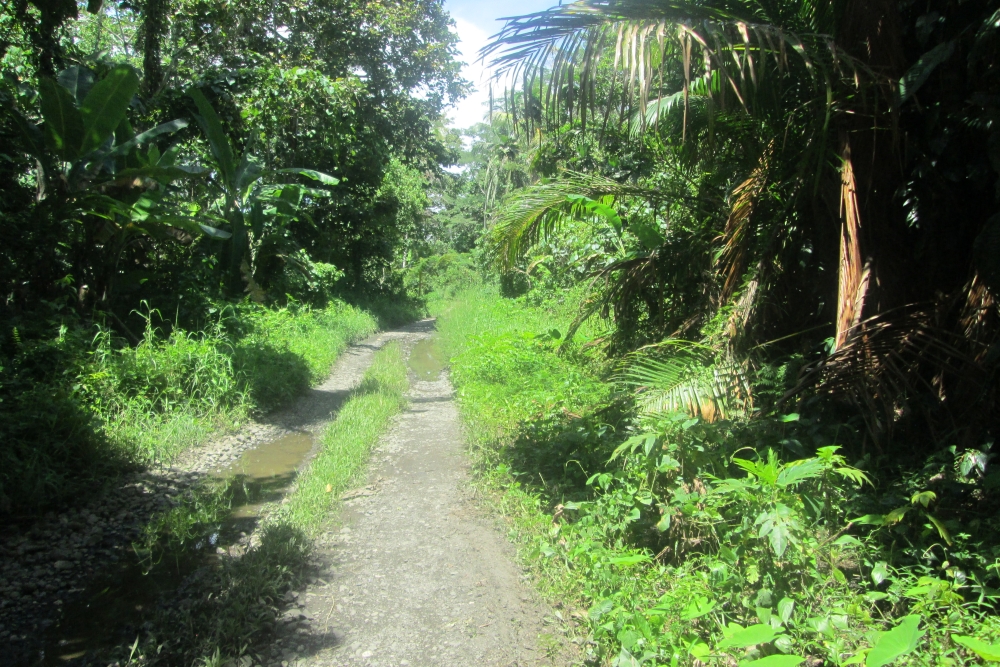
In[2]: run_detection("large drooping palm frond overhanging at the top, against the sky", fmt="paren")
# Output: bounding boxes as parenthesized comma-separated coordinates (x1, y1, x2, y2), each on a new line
(480, 0, 863, 140)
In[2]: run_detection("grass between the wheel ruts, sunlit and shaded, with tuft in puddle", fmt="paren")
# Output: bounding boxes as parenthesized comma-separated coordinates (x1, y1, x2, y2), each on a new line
(118, 343, 408, 665)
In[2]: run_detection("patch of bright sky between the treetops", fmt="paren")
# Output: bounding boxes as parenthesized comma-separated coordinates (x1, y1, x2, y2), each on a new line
(444, 0, 559, 128)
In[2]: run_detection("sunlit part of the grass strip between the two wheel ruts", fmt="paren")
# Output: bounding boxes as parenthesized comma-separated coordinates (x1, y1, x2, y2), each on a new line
(283, 343, 409, 532)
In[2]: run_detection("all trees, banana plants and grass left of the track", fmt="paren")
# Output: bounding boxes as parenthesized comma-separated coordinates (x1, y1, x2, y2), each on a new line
(0, 0, 466, 514)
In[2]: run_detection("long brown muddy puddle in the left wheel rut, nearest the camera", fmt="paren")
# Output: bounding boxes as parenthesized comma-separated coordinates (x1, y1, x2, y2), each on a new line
(40, 432, 315, 665)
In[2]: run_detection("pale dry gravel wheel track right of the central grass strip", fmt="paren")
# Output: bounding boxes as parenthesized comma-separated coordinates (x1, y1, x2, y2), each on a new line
(269, 320, 565, 667)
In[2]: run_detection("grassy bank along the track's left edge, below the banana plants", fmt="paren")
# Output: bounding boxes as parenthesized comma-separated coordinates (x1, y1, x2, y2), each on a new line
(0, 302, 377, 513)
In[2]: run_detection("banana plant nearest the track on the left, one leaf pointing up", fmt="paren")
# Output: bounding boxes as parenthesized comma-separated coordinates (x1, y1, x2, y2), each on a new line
(188, 88, 340, 301)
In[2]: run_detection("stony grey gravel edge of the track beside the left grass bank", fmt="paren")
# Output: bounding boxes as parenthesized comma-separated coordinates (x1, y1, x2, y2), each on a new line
(0, 332, 406, 665)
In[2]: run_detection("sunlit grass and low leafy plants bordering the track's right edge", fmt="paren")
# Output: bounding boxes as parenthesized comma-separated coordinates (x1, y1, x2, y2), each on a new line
(434, 287, 1000, 667)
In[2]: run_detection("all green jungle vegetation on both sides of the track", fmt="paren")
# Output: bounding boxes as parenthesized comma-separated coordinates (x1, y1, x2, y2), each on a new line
(0, 0, 1000, 667)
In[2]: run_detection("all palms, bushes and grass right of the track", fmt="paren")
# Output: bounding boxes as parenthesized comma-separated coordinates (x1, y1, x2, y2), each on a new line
(424, 0, 1000, 667)
